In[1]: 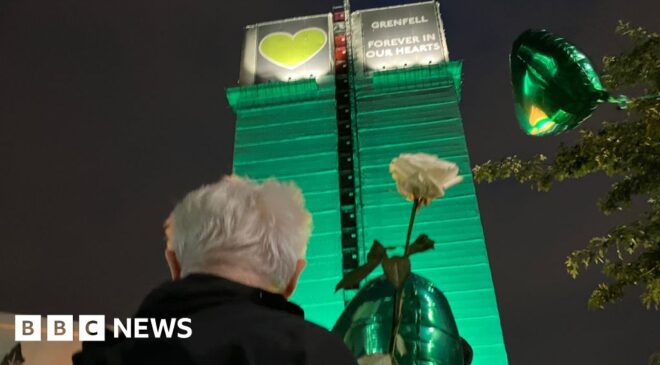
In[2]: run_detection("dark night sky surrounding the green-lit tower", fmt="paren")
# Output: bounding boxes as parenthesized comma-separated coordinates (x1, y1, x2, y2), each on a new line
(0, 0, 660, 365)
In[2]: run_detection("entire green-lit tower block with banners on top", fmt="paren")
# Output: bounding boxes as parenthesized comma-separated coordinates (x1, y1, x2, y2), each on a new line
(227, 1, 507, 365)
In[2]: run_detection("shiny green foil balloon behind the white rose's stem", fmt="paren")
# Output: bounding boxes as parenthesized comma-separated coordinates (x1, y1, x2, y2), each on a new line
(332, 274, 464, 365)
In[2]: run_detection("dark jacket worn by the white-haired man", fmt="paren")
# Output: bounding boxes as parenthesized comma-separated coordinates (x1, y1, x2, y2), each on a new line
(73, 274, 356, 365)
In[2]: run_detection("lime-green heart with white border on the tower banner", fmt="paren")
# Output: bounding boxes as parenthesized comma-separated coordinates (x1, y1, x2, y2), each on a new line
(259, 28, 328, 70)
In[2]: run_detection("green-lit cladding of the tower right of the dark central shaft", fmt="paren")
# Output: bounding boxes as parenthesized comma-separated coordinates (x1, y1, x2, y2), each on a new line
(355, 62, 507, 365)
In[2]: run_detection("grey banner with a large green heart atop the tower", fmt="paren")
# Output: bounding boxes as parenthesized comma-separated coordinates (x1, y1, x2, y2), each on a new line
(240, 14, 334, 85)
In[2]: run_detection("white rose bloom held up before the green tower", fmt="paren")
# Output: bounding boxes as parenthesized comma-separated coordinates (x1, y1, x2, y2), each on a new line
(390, 153, 463, 205)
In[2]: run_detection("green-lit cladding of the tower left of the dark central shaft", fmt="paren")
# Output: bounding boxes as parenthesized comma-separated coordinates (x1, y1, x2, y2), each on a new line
(227, 78, 344, 327)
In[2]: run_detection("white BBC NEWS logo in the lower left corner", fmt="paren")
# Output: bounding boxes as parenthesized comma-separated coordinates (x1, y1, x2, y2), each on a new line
(14, 315, 192, 342)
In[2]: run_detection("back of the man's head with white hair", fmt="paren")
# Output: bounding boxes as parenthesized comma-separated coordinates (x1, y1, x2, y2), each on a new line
(167, 175, 311, 291)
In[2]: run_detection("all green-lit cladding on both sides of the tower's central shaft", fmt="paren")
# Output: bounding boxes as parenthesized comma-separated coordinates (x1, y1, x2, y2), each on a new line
(227, 62, 507, 365)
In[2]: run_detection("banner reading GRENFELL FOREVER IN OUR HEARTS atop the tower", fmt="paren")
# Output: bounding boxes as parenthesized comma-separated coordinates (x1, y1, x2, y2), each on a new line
(352, 1, 448, 72)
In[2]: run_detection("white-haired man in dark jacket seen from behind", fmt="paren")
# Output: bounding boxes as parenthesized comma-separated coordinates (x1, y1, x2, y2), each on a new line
(74, 175, 356, 365)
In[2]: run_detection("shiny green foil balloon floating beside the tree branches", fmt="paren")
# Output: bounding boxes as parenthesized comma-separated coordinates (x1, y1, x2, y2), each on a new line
(510, 30, 609, 136)
